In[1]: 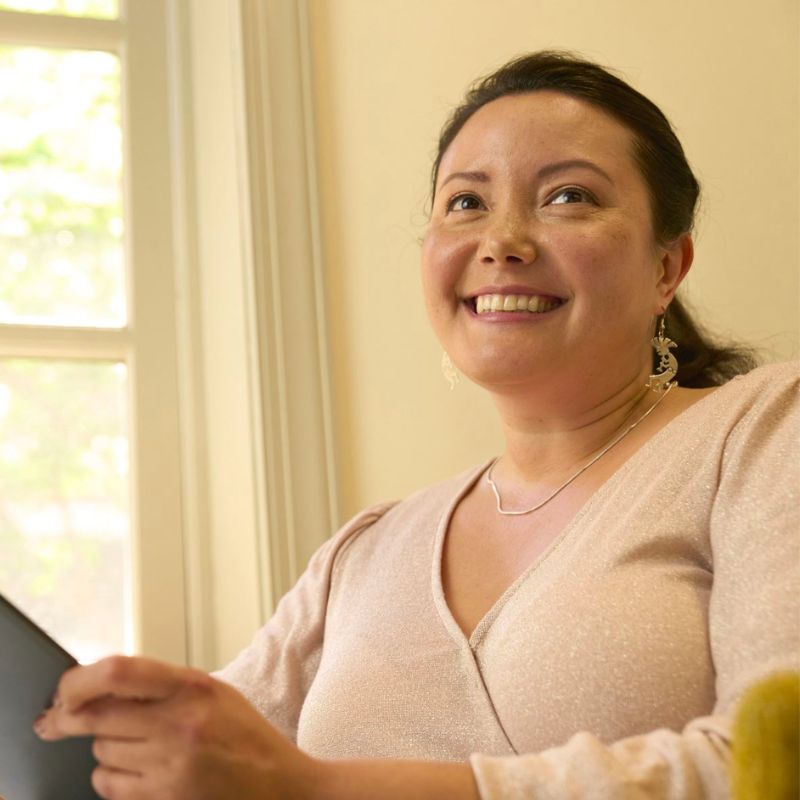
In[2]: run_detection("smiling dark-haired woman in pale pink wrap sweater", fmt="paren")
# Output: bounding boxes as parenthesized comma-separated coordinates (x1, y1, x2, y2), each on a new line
(37, 53, 800, 800)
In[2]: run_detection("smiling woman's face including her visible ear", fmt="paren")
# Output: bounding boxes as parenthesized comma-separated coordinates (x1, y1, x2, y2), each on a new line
(422, 91, 691, 396)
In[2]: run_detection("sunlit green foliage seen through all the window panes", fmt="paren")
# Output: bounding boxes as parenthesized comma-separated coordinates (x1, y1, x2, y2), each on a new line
(0, 40, 130, 658)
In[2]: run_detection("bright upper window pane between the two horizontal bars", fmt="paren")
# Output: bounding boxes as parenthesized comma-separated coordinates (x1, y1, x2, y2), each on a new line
(0, 47, 126, 327)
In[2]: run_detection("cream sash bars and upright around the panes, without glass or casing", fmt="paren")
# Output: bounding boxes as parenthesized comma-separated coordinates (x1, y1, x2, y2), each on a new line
(0, 0, 187, 662)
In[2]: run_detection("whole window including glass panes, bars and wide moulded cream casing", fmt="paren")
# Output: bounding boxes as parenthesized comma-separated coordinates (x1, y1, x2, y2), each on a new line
(0, 0, 338, 668)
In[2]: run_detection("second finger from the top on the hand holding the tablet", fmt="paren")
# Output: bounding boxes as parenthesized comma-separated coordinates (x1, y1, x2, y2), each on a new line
(34, 697, 161, 741)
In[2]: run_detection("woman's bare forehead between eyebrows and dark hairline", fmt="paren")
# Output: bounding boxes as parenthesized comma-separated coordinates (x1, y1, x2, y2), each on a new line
(439, 91, 638, 180)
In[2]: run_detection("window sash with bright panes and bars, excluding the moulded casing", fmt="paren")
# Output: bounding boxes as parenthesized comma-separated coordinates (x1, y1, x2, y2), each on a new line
(0, 0, 186, 660)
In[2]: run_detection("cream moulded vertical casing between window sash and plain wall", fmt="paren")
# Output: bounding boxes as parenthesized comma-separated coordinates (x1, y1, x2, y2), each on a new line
(171, 0, 340, 667)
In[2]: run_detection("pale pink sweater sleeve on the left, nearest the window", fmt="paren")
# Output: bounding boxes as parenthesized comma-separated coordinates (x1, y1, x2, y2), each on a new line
(214, 504, 391, 741)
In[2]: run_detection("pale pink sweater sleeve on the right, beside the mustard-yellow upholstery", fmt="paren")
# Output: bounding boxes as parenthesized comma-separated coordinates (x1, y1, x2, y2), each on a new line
(470, 373, 800, 800)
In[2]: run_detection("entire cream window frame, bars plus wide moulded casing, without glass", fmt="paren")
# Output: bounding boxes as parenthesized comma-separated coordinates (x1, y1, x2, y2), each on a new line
(0, 0, 340, 669)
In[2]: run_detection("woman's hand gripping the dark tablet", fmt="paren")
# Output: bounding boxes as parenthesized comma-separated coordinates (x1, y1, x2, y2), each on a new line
(34, 656, 322, 800)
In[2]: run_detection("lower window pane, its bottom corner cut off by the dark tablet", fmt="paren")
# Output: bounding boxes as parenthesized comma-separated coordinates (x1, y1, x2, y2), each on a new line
(0, 359, 132, 661)
